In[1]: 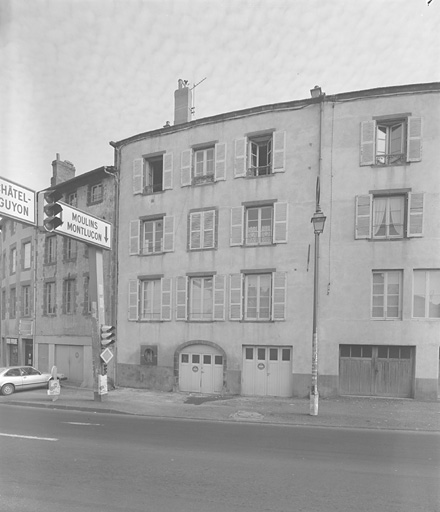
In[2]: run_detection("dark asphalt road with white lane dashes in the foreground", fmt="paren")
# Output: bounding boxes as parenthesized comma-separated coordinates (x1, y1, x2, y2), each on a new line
(0, 405, 440, 512)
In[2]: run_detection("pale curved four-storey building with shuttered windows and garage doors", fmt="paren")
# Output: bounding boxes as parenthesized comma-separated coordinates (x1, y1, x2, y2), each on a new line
(111, 81, 440, 399)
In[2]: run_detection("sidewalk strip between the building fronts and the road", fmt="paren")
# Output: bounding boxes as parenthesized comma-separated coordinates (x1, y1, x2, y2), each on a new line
(0, 383, 440, 432)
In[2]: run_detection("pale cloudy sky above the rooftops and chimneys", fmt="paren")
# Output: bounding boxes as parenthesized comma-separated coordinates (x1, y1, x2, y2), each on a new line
(0, 0, 440, 191)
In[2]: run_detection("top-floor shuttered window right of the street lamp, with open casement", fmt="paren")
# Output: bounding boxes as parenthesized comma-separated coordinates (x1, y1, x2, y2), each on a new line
(360, 114, 422, 166)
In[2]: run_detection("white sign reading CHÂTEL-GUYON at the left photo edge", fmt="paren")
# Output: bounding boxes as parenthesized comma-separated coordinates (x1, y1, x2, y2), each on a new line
(0, 177, 36, 225)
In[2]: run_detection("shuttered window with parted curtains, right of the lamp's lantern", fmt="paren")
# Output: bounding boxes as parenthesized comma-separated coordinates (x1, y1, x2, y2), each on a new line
(355, 191, 424, 240)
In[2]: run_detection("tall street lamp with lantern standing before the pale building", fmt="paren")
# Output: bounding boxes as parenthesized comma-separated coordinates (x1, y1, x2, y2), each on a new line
(310, 202, 326, 416)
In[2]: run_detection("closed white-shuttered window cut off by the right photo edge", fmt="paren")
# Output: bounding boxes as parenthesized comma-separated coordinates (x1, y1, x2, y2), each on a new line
(413, 270, 440, 318)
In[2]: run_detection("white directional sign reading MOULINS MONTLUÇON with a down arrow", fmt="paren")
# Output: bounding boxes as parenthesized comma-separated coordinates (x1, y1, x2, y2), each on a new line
(55, 201, 112, 249)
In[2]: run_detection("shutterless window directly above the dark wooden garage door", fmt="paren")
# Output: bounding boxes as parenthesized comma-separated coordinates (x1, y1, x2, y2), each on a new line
(371, 270, 402, 320)
